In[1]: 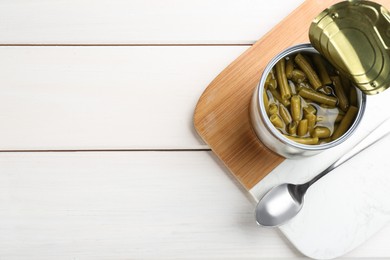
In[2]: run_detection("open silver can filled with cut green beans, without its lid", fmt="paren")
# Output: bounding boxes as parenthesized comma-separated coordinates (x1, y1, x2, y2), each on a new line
(250, 44, 365, 158)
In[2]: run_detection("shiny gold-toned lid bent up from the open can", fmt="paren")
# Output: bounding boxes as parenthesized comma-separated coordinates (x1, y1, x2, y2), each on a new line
(309, 1, 390, 94)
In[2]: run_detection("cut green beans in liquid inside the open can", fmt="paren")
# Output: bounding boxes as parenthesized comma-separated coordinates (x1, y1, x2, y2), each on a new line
(263, 49, 358, 145)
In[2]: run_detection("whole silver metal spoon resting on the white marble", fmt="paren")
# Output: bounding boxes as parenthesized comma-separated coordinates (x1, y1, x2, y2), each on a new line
(256, 119, 390, 227)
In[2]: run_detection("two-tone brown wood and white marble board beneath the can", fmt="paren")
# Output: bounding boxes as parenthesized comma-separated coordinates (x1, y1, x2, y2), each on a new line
(194, 0, 390, 259)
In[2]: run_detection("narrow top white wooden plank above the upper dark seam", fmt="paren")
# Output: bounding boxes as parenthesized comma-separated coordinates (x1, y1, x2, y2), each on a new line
(0, 0, 303, 44)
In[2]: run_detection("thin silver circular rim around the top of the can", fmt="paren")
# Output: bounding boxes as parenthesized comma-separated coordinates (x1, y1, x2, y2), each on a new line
(257, 43, 366, 151)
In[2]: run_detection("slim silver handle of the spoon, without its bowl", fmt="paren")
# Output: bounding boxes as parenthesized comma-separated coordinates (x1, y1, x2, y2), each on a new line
(301, 118, 390, 190)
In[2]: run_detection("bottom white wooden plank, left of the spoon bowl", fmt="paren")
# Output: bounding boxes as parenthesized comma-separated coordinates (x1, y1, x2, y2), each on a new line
(0, 152, 297, 259)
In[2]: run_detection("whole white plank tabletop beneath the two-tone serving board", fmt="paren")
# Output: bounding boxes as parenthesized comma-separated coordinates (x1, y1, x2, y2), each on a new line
(0, 0, 390, 259)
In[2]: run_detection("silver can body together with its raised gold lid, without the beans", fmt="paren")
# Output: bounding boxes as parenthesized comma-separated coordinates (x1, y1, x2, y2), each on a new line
(250, 1, 390, 158)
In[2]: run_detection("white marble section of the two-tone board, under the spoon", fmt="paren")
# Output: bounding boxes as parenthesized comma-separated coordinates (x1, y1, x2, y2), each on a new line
(250, 91, 390, 259)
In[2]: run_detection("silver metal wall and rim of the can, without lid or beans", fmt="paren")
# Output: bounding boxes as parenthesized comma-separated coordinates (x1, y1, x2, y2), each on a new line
(250, 44, 366, 159)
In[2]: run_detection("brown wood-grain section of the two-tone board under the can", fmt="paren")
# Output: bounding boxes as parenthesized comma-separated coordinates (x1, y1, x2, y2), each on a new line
(194, 0, 374, 190)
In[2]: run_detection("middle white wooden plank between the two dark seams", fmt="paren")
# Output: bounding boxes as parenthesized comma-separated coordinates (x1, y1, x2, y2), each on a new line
(0, 46, 247, 150)
